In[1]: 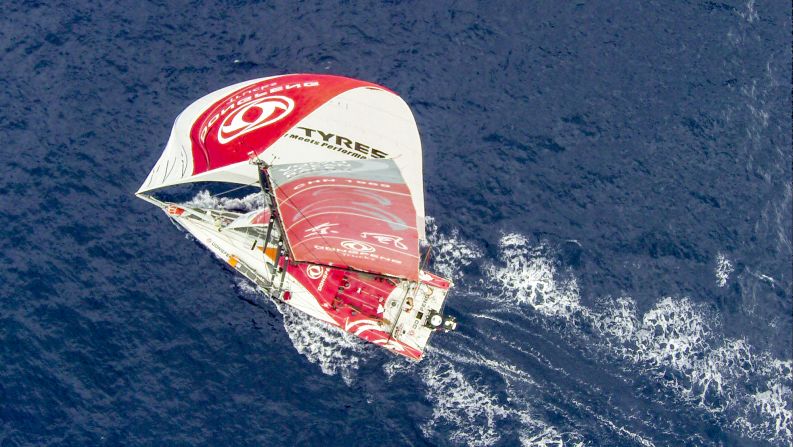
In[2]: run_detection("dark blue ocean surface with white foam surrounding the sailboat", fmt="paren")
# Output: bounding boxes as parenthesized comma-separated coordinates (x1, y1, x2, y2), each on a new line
(0, 0, 793, 447)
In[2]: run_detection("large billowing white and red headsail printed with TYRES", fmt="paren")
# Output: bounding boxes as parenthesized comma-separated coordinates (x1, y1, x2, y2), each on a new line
(138, 74, 424, 237)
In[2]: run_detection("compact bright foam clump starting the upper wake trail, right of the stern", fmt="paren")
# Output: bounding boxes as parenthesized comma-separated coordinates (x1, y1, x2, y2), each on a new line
(485, 233, 582, 318)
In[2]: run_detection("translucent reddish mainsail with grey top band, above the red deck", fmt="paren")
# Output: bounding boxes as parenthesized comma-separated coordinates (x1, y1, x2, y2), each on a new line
(269, 159, 419, 281)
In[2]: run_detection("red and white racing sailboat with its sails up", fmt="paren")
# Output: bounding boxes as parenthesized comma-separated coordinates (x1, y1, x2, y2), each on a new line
(136, 74, 457, 360)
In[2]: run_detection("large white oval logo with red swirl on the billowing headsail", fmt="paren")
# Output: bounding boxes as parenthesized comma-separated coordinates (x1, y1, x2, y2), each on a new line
(218, 96, 295, 144)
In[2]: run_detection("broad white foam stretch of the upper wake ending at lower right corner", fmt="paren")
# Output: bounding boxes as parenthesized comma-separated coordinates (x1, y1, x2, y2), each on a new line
(600, 297, 793, 443)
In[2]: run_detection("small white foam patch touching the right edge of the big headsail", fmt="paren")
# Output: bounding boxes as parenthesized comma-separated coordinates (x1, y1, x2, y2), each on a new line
(425, 216, 482, 281)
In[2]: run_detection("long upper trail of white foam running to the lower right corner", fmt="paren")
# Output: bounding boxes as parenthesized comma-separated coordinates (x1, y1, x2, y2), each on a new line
(483, 234, 793, 444)
